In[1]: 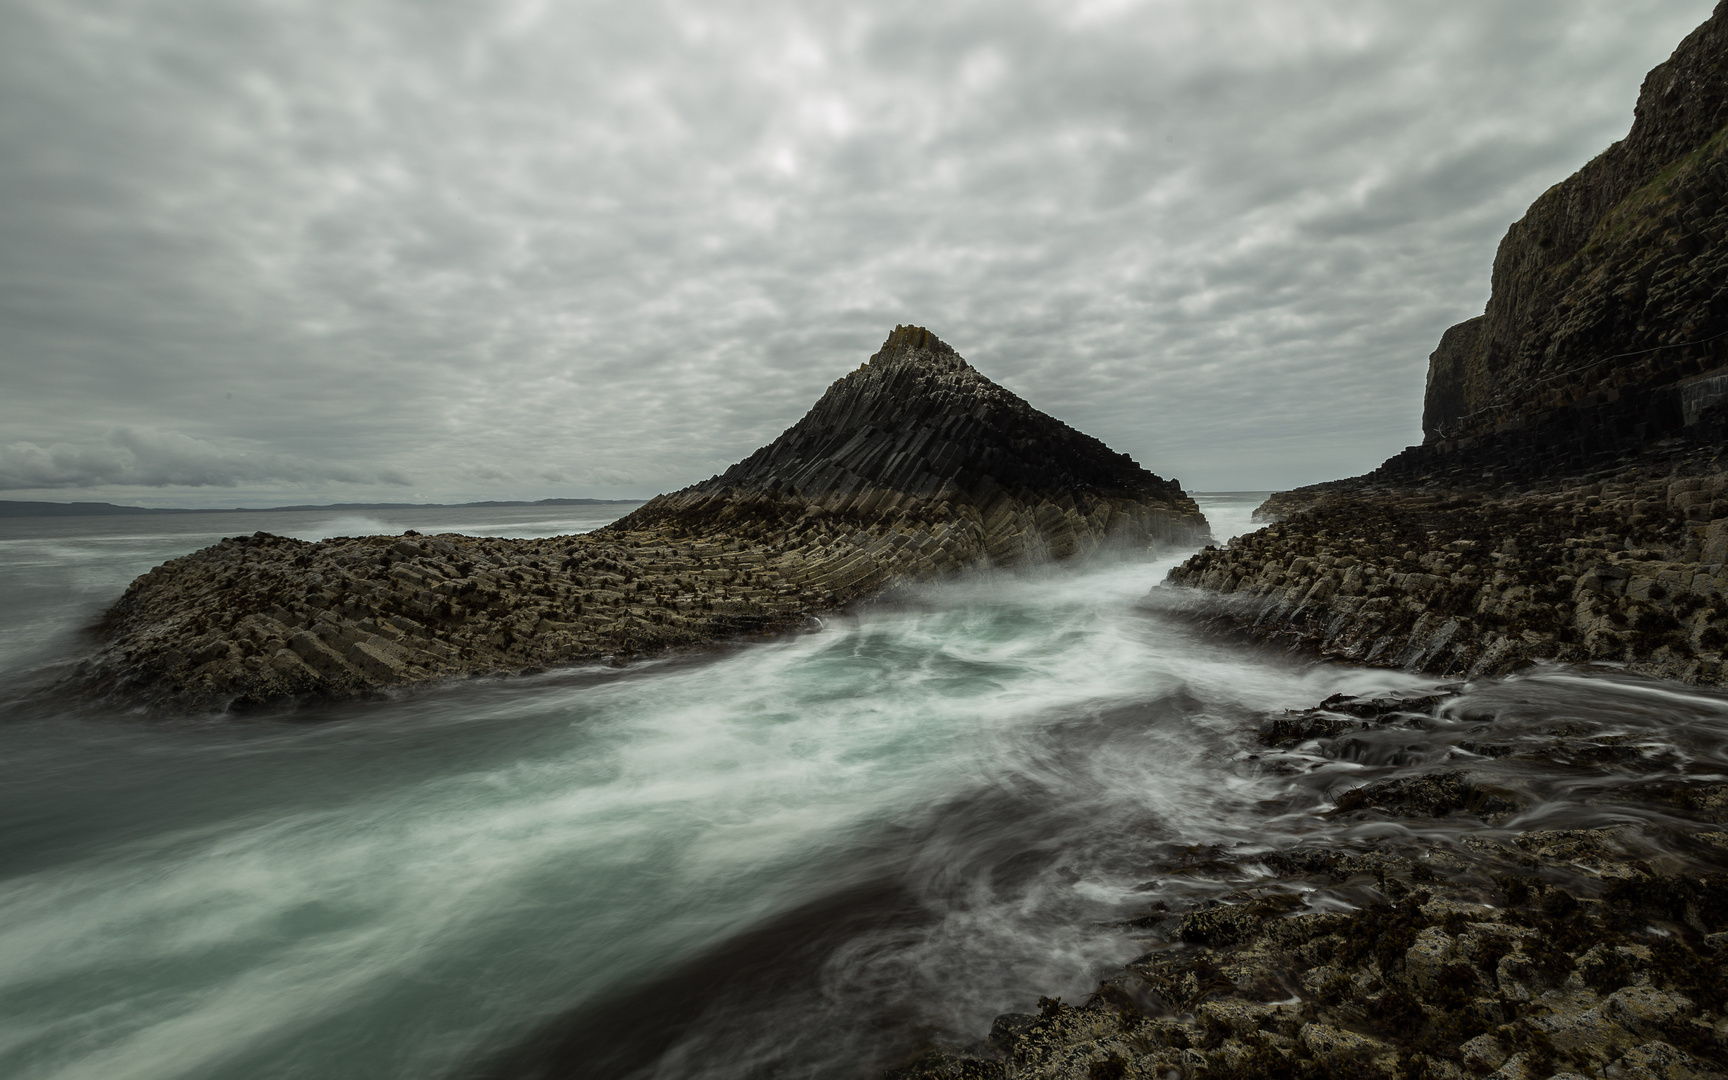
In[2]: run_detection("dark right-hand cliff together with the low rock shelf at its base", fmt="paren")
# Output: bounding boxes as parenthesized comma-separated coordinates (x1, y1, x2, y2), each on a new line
(1161, 3, 1728, 683)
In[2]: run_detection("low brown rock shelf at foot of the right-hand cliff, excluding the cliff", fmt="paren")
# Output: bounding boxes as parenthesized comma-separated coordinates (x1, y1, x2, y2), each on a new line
(1158, 461, 1728, 684)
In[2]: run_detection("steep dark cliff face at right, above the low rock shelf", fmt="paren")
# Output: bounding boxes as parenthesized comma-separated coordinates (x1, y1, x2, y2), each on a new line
(1416, 5, 1728, 472)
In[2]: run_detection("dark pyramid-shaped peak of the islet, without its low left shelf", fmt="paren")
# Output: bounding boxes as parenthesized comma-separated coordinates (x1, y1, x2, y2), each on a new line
(615, 327, 1206, 563)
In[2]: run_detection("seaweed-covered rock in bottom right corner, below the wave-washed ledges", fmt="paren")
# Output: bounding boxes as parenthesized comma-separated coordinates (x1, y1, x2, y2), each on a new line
(904, 808, 1728, 1080)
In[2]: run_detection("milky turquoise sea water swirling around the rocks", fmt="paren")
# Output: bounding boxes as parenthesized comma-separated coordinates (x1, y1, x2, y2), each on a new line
(0, 494, 1728, 1080)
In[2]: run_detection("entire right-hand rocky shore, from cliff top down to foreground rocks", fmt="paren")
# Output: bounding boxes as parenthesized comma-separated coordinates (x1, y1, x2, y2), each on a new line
(897, 3, 1728, 1080)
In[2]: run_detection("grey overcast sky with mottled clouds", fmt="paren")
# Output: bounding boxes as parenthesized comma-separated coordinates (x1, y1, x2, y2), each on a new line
(0, 0, 1711, 506)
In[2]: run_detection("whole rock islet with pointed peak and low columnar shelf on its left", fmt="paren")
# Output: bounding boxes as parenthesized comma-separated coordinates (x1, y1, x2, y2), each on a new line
(73, 327, 1206, 708)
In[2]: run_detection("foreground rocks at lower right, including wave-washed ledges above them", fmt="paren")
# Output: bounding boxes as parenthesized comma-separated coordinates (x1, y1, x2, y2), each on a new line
(890, 695, 1728, 1080)
